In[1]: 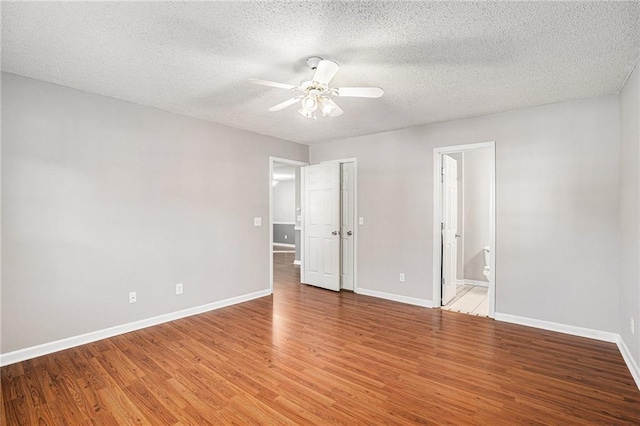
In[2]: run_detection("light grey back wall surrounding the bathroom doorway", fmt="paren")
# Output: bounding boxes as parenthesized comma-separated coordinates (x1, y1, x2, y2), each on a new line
(310, 95, 620, 332)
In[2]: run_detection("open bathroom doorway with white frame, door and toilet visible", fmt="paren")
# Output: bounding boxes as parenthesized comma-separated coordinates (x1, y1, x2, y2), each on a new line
(434, 142, 495, 317)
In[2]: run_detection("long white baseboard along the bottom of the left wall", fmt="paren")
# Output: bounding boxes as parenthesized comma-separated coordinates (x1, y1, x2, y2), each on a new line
(0, 290, 271, 366)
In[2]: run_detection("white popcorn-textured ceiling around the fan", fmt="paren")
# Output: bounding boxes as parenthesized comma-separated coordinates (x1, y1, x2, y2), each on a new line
(2, 1, 640, 144)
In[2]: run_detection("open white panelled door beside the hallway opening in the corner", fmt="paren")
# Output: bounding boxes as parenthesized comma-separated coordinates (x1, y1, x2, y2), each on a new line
(302, 163, 340, 291)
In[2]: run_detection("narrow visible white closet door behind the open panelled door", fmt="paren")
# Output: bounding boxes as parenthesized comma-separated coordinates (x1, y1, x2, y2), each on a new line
(340, 163, 355, 291)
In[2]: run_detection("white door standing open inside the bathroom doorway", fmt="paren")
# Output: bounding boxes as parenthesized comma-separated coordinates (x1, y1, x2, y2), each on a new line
(442, 155, 458, 305)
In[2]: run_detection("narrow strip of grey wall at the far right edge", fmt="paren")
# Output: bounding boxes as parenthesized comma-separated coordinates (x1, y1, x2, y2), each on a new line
(620, 60, 640, 372)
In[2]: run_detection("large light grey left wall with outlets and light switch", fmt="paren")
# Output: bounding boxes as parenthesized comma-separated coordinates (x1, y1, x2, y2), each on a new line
(1, 73, 308, 353)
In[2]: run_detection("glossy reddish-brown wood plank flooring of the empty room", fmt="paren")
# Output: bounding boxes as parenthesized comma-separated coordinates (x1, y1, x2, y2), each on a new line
(2, 254, 640, 425)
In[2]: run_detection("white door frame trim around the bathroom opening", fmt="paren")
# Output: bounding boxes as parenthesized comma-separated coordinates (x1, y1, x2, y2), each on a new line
(433, 141, 496, 318)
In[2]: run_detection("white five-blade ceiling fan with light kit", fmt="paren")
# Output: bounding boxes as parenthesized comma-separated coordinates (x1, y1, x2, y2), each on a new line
(249, 56, 384, 119)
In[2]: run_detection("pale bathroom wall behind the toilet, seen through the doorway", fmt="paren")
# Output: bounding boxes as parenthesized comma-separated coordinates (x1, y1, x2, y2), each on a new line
(462, 149, 492, 282)
